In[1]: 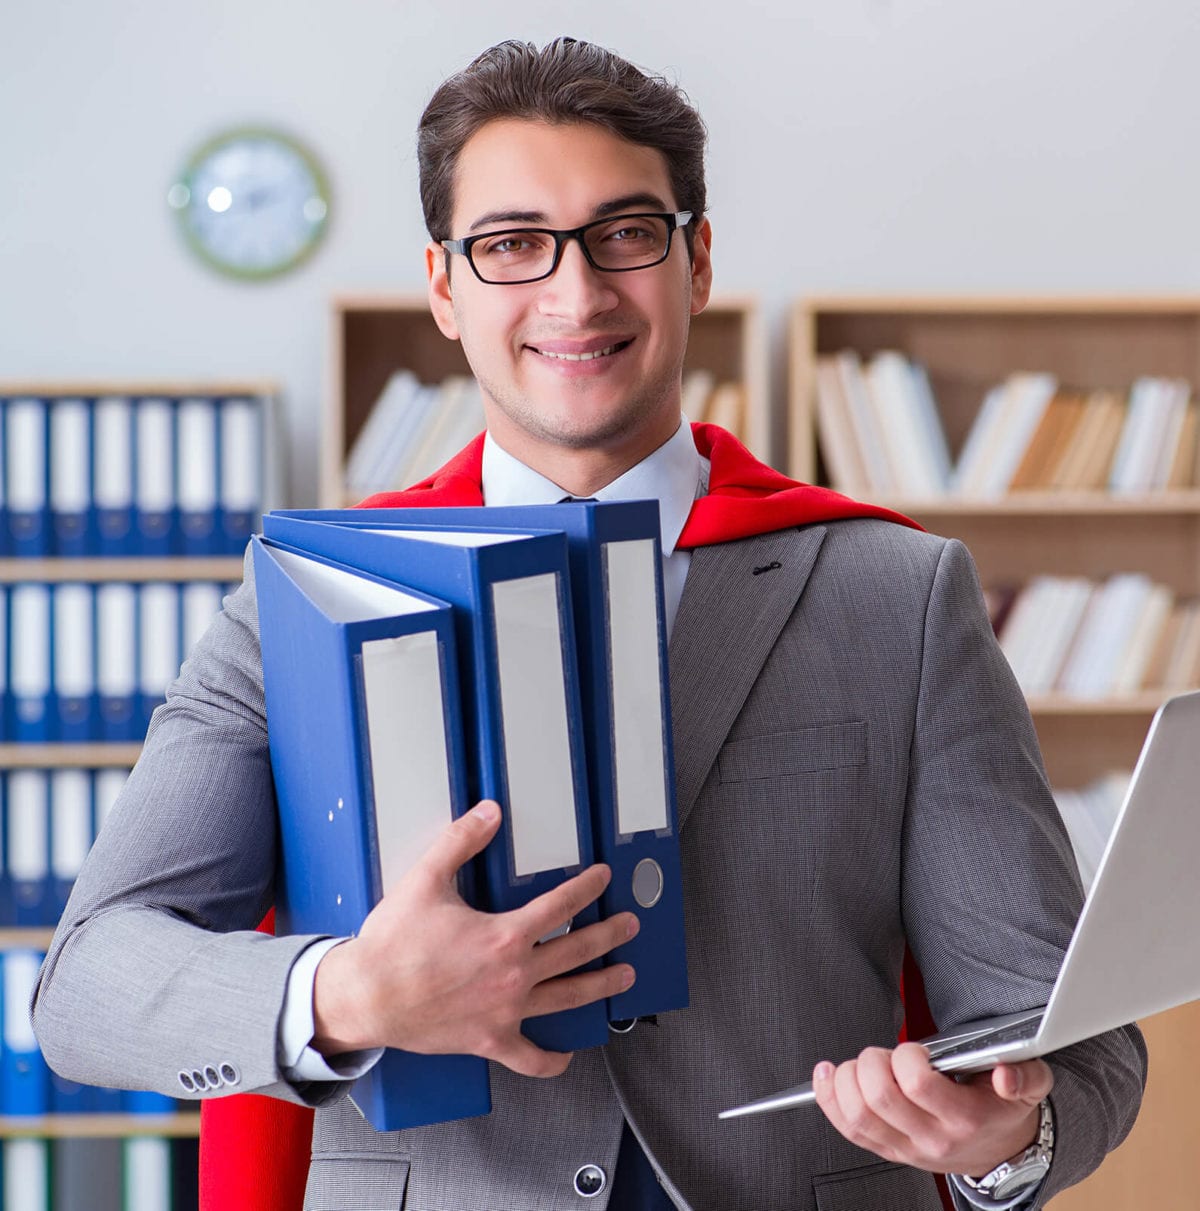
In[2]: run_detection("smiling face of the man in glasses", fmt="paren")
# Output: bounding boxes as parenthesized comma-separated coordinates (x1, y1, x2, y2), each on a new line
(426, 119, 712, 477)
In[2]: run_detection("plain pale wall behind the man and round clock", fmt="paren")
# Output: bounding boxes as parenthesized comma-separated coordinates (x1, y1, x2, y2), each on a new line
(0, 0, 1200, 504)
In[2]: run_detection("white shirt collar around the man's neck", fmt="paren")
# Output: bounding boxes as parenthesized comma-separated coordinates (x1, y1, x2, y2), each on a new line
(483, 417, 708, 556)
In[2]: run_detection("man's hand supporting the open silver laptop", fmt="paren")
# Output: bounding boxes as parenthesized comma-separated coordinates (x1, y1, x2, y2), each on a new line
(813, 1043, 1053, 1177)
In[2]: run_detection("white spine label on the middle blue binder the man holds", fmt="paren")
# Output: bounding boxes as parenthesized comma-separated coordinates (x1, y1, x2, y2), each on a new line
(492, 573, 580, 877)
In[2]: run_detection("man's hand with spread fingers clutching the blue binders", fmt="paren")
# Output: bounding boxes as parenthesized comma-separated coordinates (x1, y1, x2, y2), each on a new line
(312, 800, 638, 1077)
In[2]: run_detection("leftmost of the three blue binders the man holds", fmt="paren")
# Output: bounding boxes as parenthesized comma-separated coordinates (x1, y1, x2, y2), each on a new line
(252, 538, 492, 1131)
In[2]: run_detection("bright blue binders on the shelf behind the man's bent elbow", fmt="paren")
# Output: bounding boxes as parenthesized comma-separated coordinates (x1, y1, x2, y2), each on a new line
(0, 947, 178, 1118)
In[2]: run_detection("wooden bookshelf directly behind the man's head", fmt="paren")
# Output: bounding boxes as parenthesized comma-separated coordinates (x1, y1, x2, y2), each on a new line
(320, 294, 773, 509)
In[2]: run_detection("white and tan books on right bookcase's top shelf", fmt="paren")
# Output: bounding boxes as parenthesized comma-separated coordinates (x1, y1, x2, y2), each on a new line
(816, 350, 1200, 500)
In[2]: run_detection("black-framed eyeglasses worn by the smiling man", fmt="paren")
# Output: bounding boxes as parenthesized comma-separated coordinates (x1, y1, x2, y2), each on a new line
(442, 211, 691, 286)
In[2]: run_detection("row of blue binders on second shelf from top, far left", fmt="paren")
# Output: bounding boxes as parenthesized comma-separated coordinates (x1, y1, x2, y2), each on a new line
(0, 580, 232, 744)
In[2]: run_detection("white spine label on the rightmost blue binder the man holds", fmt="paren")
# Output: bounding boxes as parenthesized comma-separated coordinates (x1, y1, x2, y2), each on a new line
(603, 539, 670, 837)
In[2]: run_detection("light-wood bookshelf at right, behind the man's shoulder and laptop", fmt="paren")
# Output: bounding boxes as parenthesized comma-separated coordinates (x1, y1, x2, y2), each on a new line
(787, 295, 1200, 1211)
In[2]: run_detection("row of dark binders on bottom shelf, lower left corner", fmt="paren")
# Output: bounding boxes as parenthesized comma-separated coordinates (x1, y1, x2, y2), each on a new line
(0, 1135, 199, 1211)
